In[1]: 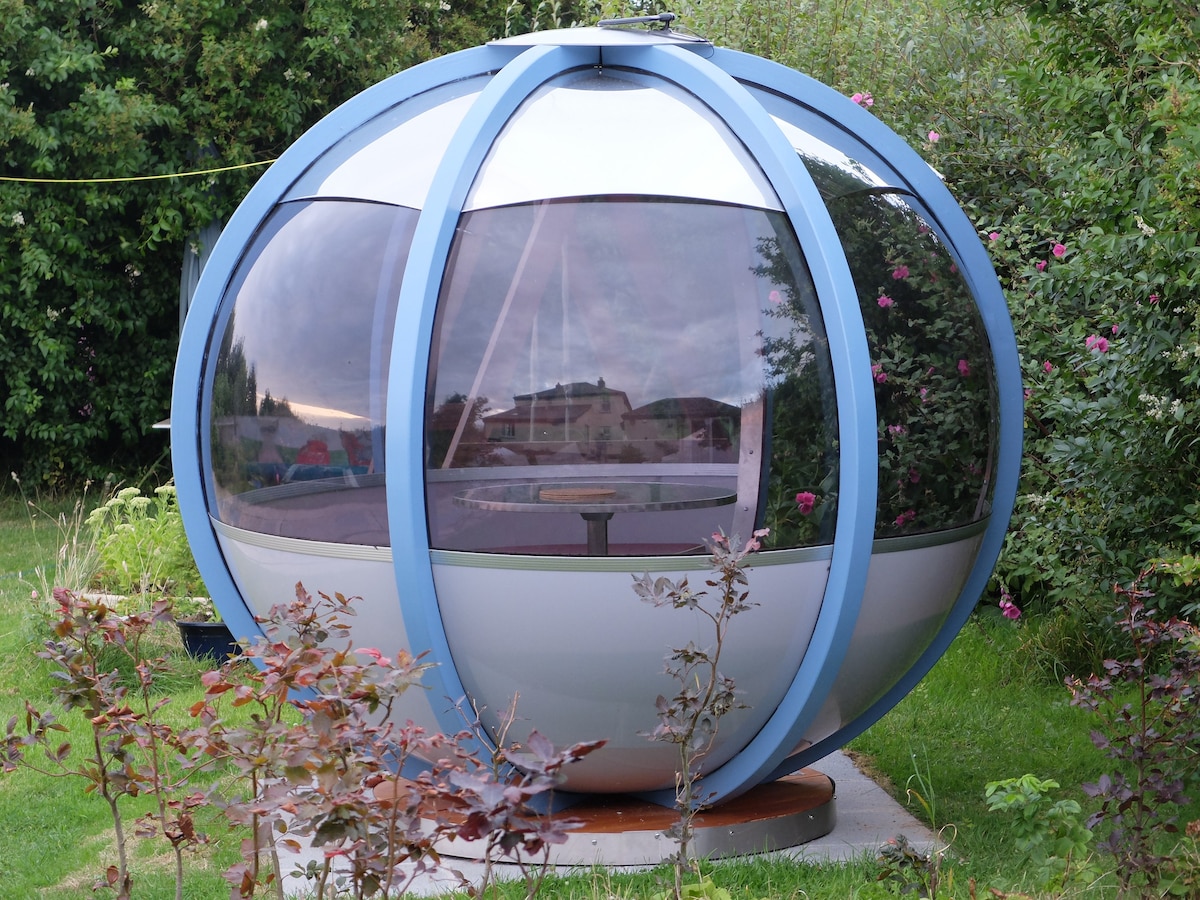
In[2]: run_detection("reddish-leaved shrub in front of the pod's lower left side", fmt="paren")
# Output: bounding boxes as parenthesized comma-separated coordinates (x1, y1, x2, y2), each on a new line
(192, 584, 604, 900)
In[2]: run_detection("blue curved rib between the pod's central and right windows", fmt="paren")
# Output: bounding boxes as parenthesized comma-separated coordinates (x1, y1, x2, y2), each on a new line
(604, 46, 878, 806)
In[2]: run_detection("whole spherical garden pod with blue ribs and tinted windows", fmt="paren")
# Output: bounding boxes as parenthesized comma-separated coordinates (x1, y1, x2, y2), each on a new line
(173, 22, 1021, 804)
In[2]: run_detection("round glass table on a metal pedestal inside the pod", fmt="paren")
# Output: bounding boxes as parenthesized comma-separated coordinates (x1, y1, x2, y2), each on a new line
(454, 481, 737, 557)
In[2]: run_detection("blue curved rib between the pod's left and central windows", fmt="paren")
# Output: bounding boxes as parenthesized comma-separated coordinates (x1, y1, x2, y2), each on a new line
(386, 40, 600, 748)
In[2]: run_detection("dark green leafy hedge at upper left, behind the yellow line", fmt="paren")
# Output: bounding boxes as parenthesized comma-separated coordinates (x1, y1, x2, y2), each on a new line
(0, 0, 553, 481)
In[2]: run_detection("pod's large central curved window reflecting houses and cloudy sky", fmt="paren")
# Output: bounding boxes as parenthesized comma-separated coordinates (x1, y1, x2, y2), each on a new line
(426, 197, 836, 556)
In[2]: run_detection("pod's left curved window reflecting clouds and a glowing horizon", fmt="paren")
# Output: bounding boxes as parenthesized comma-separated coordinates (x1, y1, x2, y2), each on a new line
(206, 200, 418, 546)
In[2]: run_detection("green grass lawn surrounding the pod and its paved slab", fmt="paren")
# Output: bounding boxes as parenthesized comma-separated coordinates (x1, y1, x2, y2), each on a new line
(0, 498, 1200, 900)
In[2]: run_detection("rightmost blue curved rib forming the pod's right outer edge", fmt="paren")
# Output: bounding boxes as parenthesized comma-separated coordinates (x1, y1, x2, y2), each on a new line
(713, 49, 1025, 778)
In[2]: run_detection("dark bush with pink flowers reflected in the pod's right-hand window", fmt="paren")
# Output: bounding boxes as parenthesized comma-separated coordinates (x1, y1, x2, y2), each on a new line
(828, 191, 995, 535)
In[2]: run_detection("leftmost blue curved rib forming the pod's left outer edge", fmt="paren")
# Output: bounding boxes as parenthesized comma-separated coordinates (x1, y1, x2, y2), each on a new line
(170, 47, 514, 657)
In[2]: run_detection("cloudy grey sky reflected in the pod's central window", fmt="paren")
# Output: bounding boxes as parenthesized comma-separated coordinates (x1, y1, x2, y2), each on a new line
(434, 198, 806, 410)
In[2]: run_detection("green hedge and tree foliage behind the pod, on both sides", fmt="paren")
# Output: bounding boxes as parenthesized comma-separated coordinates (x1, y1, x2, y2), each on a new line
(9, 0, 1200, 648)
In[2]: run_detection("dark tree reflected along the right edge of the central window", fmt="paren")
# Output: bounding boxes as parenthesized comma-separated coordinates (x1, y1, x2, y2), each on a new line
(755, 238, 838, 548)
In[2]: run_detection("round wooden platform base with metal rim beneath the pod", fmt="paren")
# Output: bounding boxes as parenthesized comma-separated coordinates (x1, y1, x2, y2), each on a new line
(439, 769, 836, 866)
